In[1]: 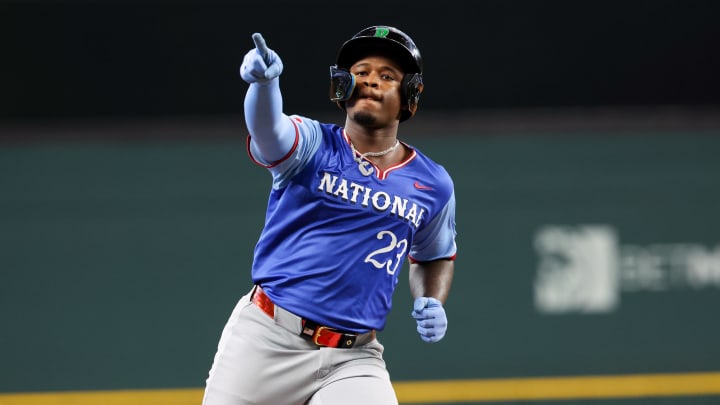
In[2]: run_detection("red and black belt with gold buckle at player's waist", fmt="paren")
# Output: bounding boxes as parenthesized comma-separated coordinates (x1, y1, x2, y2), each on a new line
(251, 286, 375, 349)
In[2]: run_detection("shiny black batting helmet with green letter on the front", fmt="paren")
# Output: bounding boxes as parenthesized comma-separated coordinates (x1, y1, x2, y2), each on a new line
(330, 25, 423, 121)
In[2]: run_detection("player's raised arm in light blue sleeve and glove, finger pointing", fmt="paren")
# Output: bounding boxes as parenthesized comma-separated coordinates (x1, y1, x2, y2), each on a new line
(240, 33, 295, 162)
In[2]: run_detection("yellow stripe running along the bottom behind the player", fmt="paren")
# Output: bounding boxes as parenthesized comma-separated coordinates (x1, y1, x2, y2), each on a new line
(0, 372, 720, 405)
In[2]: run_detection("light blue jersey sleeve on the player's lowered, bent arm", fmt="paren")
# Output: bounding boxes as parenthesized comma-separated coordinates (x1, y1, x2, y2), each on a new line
(409, 192, 457, 262)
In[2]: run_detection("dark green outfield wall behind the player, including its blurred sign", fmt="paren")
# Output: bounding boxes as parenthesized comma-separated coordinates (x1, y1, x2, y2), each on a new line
(0, 132, 720, 405)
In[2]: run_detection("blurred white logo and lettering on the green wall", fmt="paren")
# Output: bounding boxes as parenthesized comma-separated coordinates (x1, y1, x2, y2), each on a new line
(534, 224, 720, 314)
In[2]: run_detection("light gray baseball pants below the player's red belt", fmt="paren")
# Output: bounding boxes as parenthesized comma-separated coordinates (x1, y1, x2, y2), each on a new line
(203, 286, 398, 405)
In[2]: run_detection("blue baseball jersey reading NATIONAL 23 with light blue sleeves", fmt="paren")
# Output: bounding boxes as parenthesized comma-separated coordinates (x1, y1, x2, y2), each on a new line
(248, 116, 456, 333)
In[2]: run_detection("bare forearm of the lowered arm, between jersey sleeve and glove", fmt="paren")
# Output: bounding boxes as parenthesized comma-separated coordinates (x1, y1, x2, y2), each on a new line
(409, 259, 455, 303)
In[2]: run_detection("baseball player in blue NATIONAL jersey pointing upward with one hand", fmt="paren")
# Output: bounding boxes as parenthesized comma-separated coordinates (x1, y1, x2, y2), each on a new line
(203, 26, 456, 405)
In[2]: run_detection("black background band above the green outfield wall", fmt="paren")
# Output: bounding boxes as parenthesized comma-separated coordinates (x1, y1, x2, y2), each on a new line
(0, 0, 720, 120)
